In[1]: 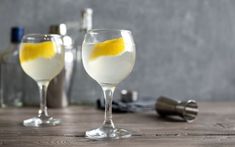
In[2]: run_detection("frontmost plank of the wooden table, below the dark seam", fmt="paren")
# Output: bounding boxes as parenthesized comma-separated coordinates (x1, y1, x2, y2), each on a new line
(0, 136, 235, 147)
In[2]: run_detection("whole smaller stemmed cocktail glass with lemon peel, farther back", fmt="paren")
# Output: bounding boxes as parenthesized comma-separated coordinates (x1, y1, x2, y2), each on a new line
(19, 34, 64, 127)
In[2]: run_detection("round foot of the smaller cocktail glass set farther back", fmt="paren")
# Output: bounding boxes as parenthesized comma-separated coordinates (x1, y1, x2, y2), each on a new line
(23, 117, 61, 127)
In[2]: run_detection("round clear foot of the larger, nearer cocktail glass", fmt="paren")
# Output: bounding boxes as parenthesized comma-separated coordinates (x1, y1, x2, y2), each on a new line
(86, 126, 131, 140)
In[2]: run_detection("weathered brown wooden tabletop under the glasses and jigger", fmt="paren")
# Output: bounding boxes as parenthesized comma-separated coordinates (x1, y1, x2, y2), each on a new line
(0, 102, 235, 147)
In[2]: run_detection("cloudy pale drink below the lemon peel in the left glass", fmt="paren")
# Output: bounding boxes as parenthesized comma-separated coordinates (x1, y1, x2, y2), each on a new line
(21, 54, 64, 82)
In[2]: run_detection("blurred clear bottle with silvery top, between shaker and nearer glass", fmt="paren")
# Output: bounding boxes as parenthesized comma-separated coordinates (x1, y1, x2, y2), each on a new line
(71, 8, 93, 104)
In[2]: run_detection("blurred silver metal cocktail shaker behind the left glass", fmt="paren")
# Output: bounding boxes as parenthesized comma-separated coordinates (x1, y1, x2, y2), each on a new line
(47, 24, 76, 108)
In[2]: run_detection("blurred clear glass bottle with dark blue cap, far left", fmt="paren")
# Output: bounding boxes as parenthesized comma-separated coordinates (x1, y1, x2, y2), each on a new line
(0, 27, 26, 107)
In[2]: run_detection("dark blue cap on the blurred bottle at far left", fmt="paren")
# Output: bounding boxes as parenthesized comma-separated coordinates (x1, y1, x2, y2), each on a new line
(11, 26, 24, 43)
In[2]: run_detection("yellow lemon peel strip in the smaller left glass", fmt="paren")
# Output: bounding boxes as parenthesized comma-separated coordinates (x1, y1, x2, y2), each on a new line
(20, 41, 55, 63)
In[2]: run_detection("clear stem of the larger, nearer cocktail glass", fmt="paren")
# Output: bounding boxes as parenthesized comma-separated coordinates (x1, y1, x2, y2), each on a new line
(102, 86, 115, 128)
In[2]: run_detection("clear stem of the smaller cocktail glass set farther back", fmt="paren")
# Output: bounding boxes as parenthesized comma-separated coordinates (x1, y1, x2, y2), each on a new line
(38, 82, 49, 118)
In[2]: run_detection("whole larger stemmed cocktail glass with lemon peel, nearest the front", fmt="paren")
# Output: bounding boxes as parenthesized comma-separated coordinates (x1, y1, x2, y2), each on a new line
(82, 29, 136, 140)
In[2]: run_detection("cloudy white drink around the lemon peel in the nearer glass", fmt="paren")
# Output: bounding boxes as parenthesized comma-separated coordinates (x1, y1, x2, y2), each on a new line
(82, 43, 135, 85)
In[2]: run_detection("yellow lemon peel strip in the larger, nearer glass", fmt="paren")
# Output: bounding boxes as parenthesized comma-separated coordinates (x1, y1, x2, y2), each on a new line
(90, 38, 125, 60)
